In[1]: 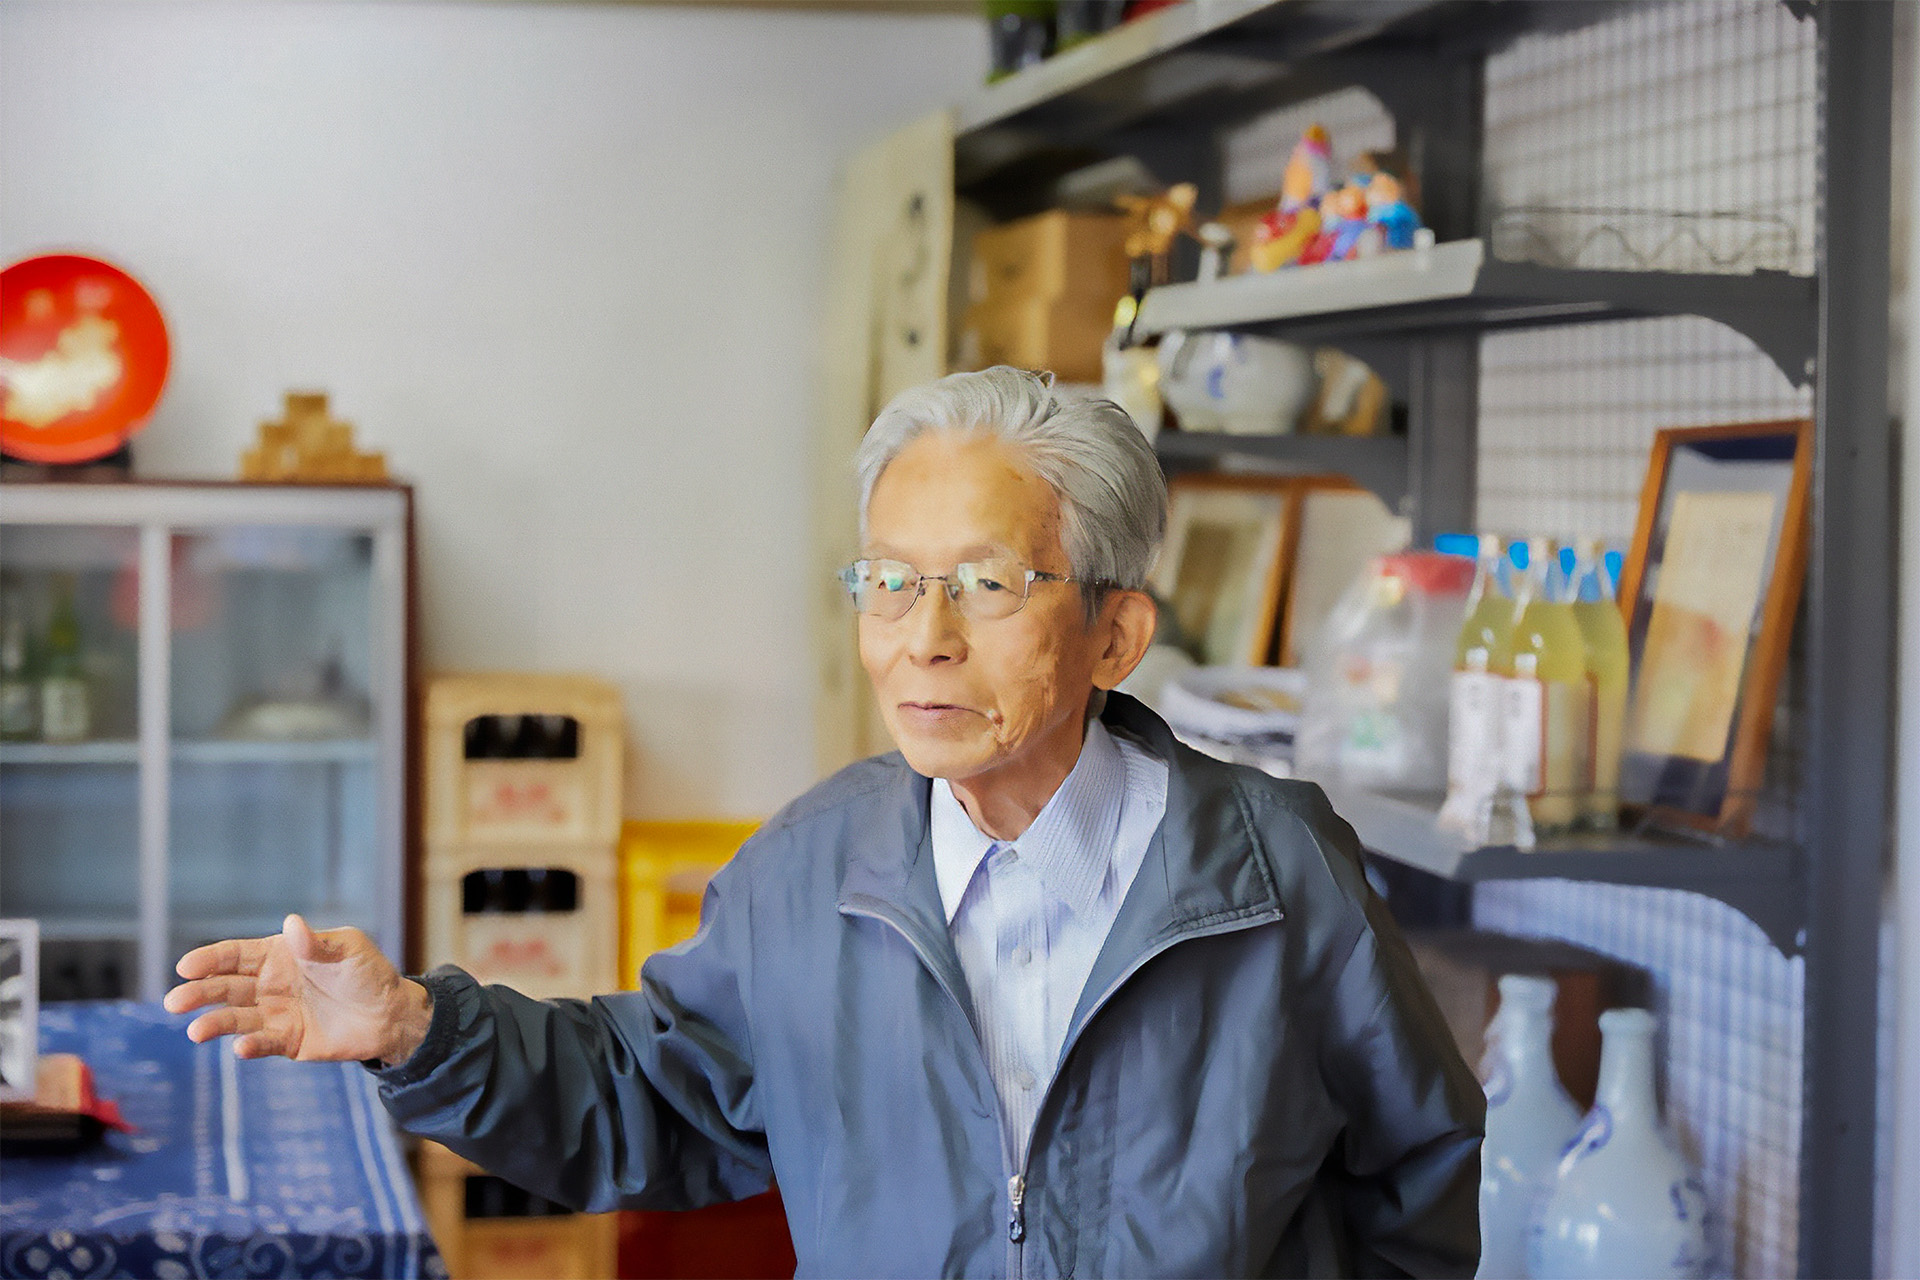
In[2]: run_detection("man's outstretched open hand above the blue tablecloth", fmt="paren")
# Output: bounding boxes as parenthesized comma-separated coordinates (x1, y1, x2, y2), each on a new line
(165, 915, 432, 1063)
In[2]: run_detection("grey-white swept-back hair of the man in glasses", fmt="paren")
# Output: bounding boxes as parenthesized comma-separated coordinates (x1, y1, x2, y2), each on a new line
(854, 365, 1167, 614)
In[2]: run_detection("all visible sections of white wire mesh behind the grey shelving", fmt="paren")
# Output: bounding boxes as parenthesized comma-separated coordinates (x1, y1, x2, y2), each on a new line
(1475, 0, 1816, 1276)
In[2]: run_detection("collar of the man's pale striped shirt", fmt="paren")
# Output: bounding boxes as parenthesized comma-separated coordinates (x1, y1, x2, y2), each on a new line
(927, 720, 1127, 925)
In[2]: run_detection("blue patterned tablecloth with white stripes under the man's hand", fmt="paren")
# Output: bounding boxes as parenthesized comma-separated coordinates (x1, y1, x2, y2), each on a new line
(0, 1002, 445, 1280)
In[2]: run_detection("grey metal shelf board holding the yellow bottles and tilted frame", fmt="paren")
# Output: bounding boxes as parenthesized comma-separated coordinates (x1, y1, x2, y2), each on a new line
(1321, 781, 1807, 956)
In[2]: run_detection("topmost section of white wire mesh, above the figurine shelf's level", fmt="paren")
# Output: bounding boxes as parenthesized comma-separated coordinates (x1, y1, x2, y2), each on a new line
(1486, 0, 1818, 274)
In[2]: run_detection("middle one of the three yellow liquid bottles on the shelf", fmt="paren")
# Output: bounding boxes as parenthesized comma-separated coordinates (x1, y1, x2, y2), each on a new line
(1498, 537, 1592, 835)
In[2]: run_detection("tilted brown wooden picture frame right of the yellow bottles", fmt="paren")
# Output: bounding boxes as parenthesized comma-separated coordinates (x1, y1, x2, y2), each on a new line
(1620, 418, 1814, 839)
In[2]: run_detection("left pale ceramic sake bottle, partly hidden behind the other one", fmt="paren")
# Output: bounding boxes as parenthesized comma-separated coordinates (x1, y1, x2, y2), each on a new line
(1478, 973, 1580, 1280)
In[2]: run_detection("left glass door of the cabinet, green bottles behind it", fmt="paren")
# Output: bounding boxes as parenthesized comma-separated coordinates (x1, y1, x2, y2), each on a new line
(0, 524, 140, 1000)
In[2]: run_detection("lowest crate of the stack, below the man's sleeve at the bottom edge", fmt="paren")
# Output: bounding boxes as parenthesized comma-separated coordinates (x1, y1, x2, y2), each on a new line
(420, 1142, 620, 1280)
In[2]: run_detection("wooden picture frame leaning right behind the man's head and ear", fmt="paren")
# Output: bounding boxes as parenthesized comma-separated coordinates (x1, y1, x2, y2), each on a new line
(1148, 472, 1354, 666)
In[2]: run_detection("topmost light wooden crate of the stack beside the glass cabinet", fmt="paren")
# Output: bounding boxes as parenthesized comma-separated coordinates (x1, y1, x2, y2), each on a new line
(424, 672, 626, 848)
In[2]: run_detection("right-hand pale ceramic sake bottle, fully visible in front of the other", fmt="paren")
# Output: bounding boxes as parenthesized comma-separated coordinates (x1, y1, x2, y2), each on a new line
(1526, 1009, 1709, 1280)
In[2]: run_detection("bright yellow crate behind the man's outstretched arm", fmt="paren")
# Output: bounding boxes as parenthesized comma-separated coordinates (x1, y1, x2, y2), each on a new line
(620, 821, 760, 990)
